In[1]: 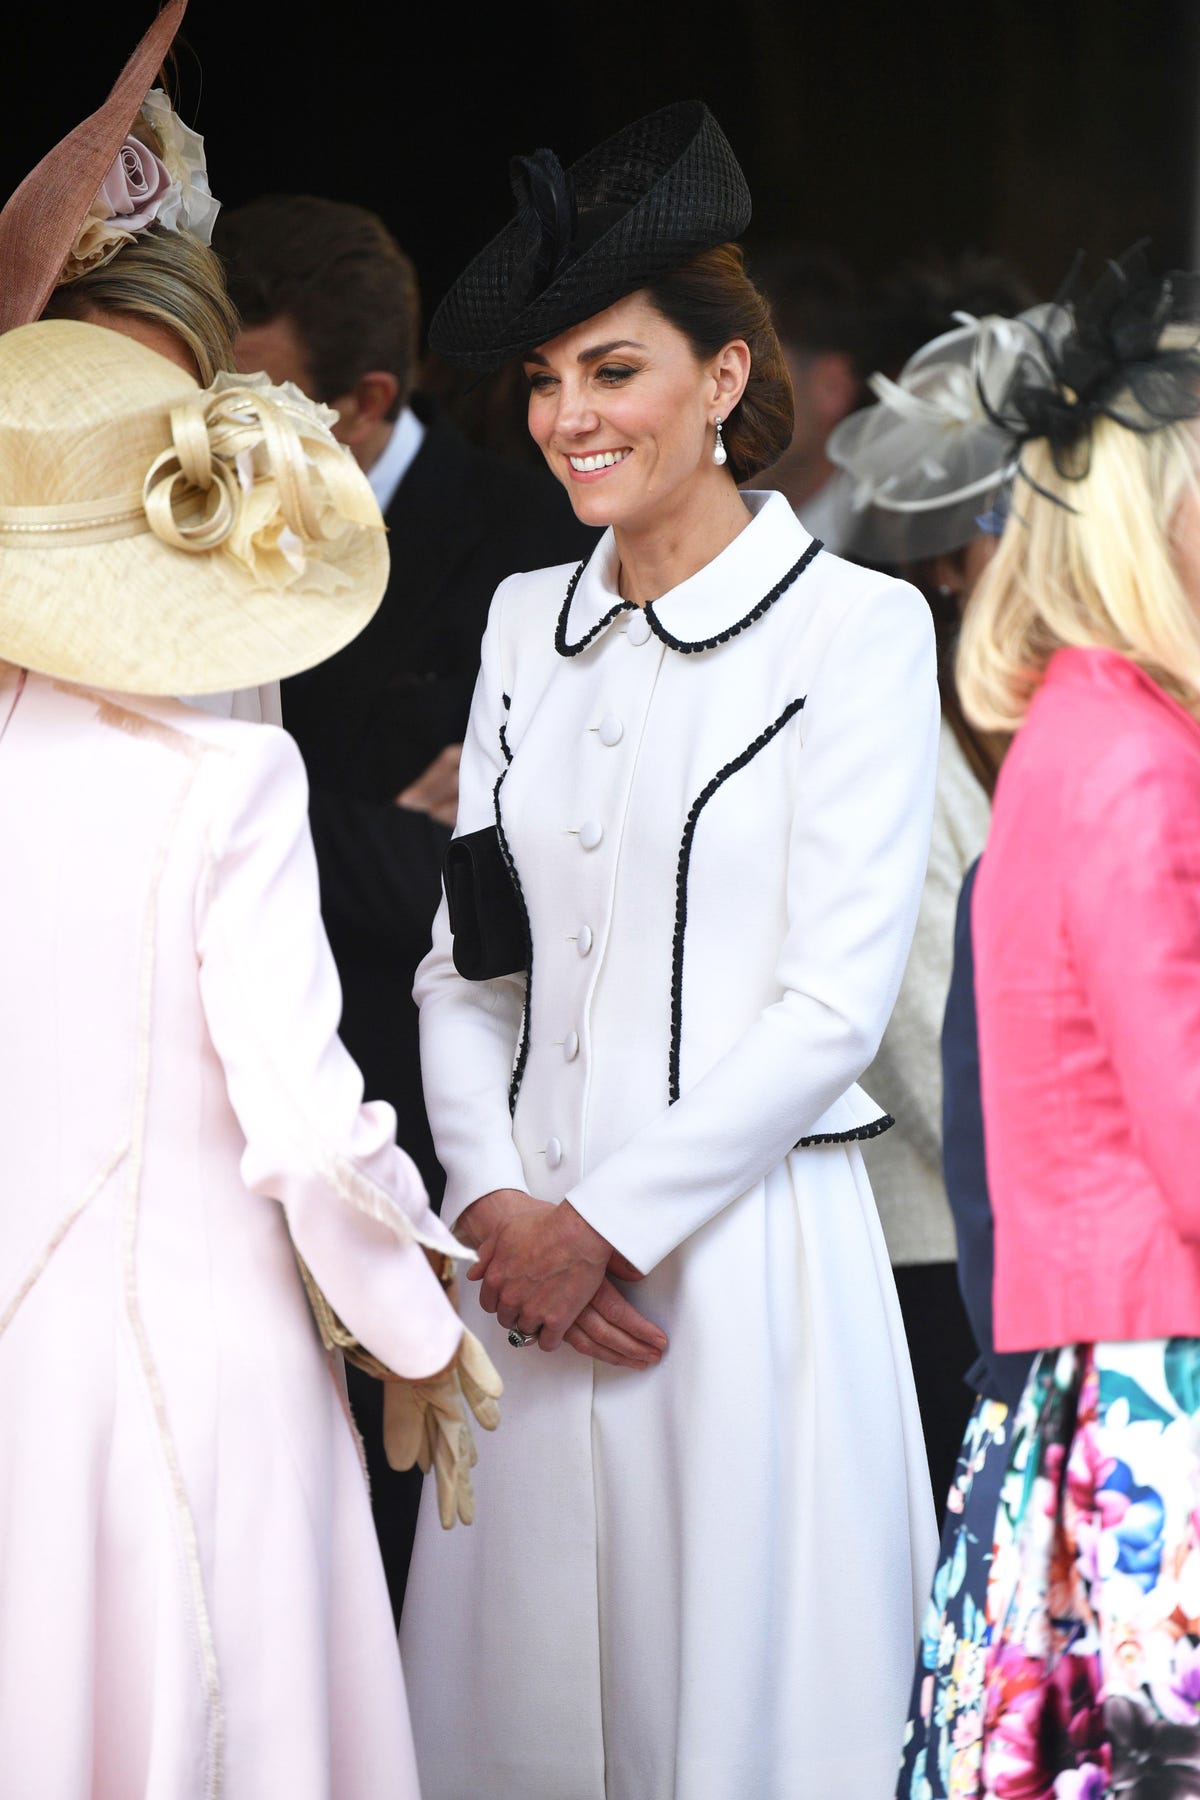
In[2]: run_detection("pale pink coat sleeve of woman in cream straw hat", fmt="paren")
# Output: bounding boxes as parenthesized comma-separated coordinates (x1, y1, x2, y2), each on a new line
(196, 727, 462, 1379)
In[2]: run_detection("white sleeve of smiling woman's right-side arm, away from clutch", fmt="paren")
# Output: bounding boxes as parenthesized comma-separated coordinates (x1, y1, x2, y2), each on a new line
(567, 583, 939, 1273)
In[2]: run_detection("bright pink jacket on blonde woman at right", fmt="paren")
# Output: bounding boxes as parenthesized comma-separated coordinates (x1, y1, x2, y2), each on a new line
(973, 650, 1200, 1350)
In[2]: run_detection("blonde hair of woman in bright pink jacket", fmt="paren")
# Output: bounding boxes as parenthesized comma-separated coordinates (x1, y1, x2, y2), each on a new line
(957, 405, 1200, 733)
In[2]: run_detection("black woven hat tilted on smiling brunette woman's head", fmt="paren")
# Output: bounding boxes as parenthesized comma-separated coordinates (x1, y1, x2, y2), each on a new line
(430, 101, 750, 369)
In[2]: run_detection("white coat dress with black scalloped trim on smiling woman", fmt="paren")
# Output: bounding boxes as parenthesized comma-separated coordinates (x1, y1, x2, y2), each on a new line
(401, 493, 937, 1800)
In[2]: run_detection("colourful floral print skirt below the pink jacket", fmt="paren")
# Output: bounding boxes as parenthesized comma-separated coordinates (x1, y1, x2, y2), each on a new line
(898, 1337, 1200, 1800)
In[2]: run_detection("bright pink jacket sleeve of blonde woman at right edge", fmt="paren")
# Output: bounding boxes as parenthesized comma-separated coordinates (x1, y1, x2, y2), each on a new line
(1065, 736, 1200, 1240)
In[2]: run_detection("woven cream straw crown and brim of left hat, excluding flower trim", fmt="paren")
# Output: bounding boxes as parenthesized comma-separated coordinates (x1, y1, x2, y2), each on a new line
(0, 320, 389, 695)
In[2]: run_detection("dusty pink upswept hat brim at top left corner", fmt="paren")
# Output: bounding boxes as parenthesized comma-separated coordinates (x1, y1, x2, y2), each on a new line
(0, 0, 187, 331)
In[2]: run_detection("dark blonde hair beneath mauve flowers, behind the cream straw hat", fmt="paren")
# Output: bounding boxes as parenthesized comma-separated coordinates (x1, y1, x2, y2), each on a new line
(41, 225, 237, 387)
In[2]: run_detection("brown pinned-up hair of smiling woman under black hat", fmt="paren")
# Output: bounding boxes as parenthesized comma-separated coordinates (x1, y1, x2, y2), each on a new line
(644, 243, 793, 482)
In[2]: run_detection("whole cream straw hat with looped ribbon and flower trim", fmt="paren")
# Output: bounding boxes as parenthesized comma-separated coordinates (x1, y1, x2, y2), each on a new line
(0, 320, 387, 695)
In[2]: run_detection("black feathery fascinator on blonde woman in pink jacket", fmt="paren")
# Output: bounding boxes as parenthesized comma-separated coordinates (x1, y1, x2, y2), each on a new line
(981, 245, 1200, 499)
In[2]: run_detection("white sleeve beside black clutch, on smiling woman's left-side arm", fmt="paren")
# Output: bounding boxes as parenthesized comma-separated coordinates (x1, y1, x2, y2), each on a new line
(412, 583, 527, 1224)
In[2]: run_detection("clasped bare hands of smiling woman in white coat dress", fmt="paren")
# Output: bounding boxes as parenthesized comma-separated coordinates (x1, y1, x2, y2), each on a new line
(457, 1188, 667, 1368)
